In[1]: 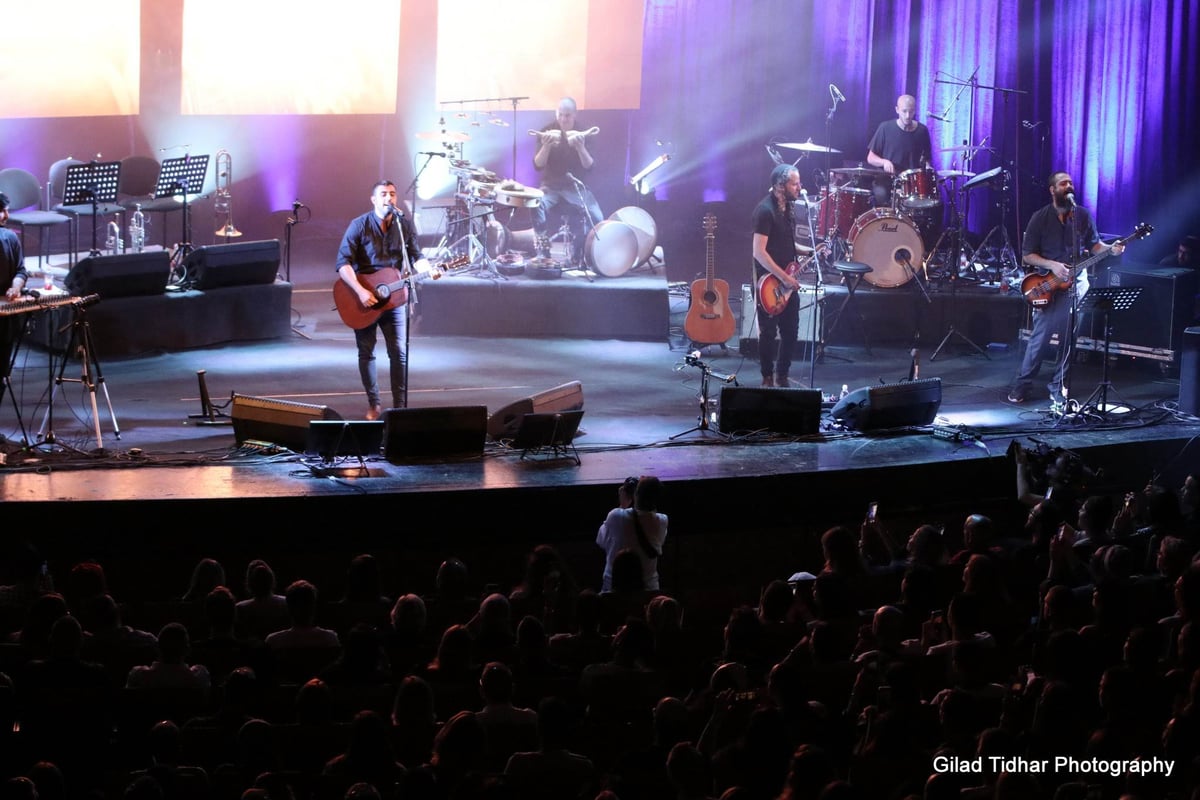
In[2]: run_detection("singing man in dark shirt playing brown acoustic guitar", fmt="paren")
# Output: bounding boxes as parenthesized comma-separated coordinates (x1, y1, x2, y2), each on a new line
(337, 180, 430, 420)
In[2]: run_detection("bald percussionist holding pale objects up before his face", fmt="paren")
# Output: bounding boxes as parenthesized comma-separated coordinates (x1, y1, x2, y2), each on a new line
(533, 97, 604, 256)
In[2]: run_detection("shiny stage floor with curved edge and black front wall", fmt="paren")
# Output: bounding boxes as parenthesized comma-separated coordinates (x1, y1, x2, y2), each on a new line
(0, 253, 1200, 609)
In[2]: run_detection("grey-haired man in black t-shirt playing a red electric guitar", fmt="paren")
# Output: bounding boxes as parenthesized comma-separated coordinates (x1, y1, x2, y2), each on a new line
(752, 163, 800, 387)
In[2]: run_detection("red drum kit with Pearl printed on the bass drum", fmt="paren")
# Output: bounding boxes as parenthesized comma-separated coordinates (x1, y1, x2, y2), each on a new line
(774, 142, 1001, 289)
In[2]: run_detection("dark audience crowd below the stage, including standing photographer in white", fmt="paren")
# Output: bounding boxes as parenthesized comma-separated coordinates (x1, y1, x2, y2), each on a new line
(0, 470, 1200, 800)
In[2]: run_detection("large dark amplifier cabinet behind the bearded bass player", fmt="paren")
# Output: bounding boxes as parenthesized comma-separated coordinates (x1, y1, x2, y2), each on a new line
(1079, 261, 1196, 354)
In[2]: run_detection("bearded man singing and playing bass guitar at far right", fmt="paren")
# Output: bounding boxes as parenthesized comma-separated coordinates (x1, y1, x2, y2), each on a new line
(1008, 172, 1124, 411)
